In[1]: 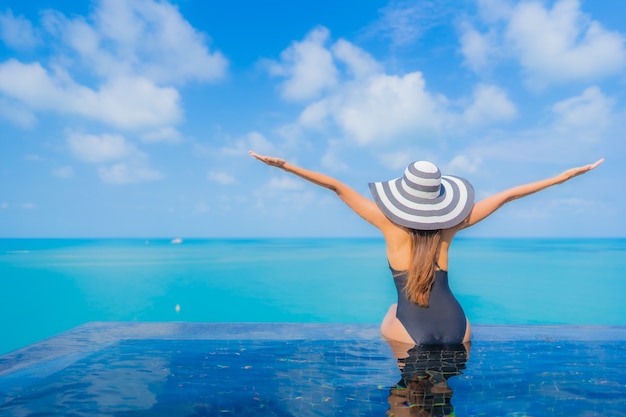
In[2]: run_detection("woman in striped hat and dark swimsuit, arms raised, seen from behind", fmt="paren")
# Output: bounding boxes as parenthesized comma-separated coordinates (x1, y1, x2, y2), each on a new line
(250, 151, 604, 345)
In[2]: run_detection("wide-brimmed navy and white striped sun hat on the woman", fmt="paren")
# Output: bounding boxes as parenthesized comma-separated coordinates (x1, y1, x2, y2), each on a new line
(370, 161, 474, 230)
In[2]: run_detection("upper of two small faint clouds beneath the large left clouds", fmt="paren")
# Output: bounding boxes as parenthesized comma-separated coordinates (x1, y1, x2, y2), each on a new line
(67, 132, 139, 162)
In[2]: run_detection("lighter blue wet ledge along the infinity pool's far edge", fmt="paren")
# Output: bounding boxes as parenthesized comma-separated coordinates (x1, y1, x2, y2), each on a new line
(0, 322, 626, 379)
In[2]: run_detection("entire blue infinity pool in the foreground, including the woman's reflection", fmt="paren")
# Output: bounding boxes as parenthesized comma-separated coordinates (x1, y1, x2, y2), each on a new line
(0, 323, 626, 417)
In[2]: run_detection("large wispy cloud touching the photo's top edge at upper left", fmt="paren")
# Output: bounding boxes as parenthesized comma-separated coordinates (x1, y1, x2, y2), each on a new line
(39, 0, 227, 84)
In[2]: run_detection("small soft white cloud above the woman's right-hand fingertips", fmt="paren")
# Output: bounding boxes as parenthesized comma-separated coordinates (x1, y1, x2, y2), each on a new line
(552, 87, 614, 141)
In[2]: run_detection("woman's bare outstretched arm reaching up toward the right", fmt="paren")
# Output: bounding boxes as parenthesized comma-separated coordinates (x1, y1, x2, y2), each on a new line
(460, 159, 604, 229)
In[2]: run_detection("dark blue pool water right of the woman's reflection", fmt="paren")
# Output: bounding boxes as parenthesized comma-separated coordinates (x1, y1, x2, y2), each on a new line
(456, 341, 626, 416)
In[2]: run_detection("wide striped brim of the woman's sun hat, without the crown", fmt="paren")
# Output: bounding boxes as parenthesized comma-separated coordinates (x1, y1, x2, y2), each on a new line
(369, 175, 474, 230)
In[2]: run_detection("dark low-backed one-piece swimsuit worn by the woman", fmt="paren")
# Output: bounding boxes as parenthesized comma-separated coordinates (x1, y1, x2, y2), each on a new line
(389, 266, 467, 345)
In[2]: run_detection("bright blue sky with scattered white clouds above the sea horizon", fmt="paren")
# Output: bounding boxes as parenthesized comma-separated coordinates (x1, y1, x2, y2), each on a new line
(0, 0, 626, 238)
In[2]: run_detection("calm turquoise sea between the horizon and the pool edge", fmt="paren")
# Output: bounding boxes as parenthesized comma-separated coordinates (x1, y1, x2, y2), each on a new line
(0, 238, 626, 354)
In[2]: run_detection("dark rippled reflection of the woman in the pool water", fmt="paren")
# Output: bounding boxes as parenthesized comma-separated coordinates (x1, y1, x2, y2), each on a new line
(387, 343, 471, 417)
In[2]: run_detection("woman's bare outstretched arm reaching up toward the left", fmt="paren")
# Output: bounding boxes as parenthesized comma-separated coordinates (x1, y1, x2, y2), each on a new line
(249, 151, 391, 230)
